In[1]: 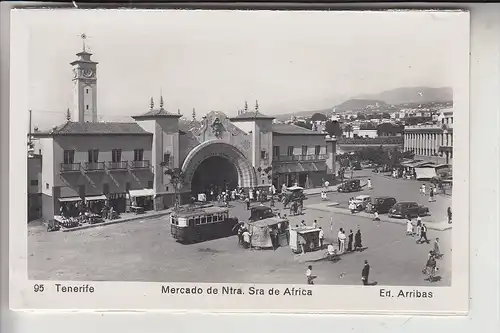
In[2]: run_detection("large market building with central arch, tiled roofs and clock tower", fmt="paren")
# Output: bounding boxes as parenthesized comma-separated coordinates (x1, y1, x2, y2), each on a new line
(30, 44, 336, 220)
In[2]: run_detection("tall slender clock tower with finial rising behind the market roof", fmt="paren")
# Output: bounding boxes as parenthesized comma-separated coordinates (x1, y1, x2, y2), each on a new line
(70, 34, 98, 122)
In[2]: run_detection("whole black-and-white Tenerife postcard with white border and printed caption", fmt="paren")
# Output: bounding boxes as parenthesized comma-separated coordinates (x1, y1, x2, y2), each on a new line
(9, 10, 469, 314)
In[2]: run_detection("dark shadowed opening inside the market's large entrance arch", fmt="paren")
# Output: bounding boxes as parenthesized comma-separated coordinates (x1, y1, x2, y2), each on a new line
(191, 156, 238, 197)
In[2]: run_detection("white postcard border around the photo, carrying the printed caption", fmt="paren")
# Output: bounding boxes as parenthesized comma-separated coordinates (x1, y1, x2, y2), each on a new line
(9, 10, 469, 314)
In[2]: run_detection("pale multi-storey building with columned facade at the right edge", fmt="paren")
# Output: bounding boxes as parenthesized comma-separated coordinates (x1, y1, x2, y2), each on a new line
(404, 109, 453, 164)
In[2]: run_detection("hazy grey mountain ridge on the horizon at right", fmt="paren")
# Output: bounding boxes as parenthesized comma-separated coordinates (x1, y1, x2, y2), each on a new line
(357, 87, 453, 105)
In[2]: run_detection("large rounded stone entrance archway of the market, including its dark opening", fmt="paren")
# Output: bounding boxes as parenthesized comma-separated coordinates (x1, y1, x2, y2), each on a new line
(182, 140, 257, 193)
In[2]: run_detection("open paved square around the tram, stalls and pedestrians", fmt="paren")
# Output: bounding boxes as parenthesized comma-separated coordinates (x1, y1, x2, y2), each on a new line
(28, 170, 451, 286)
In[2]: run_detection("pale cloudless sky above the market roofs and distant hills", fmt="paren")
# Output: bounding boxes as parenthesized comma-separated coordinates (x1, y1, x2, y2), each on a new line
(18, 10, 468, 129)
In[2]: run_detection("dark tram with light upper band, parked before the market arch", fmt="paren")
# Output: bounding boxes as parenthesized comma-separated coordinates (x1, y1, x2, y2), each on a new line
(170, 207, 238, 243)
